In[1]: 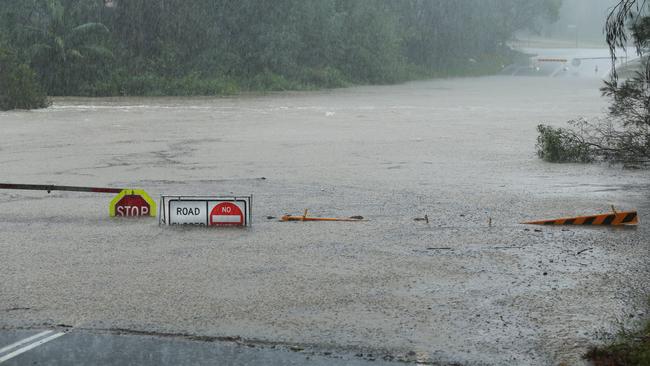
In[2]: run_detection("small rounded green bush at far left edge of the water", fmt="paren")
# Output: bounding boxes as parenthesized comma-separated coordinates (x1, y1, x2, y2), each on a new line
(0, 40, 48, 110)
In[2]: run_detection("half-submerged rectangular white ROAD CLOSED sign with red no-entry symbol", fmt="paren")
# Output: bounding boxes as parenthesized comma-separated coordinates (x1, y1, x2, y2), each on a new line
(159, 196, 252, 227)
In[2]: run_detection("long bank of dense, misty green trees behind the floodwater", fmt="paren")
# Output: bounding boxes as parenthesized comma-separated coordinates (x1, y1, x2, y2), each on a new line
(0, 0, 560, 95)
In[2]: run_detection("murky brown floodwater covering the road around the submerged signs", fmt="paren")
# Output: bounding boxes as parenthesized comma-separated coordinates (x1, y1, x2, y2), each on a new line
(0, 76, 650, 365)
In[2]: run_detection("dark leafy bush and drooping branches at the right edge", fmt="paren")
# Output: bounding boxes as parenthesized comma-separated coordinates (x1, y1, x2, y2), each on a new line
(537, 0, 650, 167)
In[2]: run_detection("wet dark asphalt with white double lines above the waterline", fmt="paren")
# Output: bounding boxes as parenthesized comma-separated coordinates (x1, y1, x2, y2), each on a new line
(0, 328, 389, 366)
